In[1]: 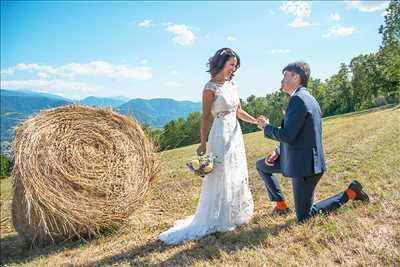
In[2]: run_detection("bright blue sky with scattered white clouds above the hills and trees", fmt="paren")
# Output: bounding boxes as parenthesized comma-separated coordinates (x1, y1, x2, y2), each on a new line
(1, 1, 388, 101)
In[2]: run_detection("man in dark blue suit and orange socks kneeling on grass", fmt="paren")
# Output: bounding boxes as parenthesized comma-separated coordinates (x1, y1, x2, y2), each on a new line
(256, 62, 369, 222)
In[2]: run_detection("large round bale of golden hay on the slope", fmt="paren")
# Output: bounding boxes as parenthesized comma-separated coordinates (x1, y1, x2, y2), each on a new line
(11, 105, 159, 247)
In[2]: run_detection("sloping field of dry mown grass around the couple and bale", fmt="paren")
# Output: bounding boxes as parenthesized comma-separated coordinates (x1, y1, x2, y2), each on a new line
(0, 106, 400, 266)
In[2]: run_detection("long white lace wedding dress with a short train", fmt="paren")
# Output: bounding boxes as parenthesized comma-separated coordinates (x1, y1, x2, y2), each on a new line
(159, 81, 254, 244)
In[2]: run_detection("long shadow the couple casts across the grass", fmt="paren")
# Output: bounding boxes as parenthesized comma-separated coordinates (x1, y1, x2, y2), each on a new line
(84, 219, 296, 267)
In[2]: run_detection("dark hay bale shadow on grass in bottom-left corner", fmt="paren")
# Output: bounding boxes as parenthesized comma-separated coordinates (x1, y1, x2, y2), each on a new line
(0, 234, 84, 266)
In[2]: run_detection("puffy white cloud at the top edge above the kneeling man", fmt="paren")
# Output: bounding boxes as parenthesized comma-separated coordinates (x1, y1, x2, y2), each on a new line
(280, 1, 316, 28)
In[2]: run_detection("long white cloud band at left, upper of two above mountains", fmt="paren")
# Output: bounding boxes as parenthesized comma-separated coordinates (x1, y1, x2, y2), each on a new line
(1, 61, 152, 80)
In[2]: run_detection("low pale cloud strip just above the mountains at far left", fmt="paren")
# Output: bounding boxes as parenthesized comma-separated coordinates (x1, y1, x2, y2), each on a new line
(0, 80, 100, 96)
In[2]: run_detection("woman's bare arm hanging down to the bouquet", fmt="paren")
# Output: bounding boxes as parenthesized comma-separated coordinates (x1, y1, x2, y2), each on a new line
(197, 90, 214, 155)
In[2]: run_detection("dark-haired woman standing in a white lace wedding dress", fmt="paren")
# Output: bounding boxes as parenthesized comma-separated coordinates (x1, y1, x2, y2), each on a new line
(159, 48, 257, 244)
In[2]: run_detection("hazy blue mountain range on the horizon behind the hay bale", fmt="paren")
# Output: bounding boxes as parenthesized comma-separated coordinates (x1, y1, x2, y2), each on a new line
(0, 89, 201, 144)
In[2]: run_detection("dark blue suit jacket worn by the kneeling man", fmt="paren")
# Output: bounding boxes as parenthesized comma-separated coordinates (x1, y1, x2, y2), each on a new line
(264, 87, 326, 177)
